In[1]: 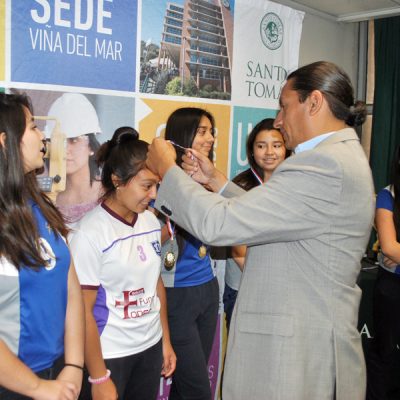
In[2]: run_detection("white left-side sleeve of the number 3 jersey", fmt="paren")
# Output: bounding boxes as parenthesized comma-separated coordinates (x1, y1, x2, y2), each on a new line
(70, 230, 102, 289)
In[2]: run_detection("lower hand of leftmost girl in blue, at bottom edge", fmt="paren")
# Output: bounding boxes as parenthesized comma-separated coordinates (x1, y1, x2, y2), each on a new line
(29, 379, 79, 400)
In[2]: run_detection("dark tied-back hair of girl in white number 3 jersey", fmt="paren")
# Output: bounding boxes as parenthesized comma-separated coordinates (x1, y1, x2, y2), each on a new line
(97, 126, 149, 200)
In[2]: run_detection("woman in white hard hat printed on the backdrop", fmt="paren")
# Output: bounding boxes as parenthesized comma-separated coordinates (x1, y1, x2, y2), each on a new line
(45, 93, 101, 223)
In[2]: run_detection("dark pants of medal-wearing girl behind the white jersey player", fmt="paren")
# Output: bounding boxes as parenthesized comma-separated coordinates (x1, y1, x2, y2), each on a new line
(166, 278, 219, 400)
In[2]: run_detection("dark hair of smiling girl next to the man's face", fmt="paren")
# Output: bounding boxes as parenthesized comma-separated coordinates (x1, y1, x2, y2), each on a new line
(232, 118, 290, 191)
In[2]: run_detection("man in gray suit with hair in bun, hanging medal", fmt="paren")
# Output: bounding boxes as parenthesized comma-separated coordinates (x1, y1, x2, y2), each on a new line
(147, 62, 374, 400)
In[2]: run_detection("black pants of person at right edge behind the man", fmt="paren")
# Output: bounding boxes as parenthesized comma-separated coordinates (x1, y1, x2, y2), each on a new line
(366, 268, 400, 400)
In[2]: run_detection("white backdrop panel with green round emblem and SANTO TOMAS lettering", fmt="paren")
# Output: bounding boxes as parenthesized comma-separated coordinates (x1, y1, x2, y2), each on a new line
(232, 0, 304, 109)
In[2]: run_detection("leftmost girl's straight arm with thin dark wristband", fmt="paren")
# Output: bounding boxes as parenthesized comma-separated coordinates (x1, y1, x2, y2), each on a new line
(57, 262, 85, 391)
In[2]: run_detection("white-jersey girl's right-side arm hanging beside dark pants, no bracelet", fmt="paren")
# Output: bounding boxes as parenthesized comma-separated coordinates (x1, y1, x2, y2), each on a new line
(157, 277, 176, 378)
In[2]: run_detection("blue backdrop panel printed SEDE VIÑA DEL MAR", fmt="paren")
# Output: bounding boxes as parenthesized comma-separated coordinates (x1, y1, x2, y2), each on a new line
(11, 0, 137, 91)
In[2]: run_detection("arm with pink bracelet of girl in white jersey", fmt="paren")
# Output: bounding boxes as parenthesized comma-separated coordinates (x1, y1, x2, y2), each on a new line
(82, 289, 118, 400)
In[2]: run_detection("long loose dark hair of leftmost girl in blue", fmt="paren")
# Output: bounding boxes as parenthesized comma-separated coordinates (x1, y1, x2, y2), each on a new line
(0, 93, 68, 269)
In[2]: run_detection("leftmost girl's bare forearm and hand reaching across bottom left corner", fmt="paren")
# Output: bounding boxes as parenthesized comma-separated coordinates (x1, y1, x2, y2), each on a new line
(0, 339, 79, 400)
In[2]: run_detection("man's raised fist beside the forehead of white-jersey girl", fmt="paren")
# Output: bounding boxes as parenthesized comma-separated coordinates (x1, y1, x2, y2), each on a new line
(146, 138, 176, 179)
